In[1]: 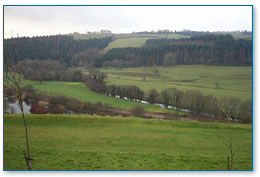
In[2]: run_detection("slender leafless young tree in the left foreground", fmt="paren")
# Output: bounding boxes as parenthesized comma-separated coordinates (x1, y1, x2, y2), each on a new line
(4, 47, 32, 170)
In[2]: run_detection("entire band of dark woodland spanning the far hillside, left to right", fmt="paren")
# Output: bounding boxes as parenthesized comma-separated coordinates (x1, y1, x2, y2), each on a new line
(4, 34, 252, 67)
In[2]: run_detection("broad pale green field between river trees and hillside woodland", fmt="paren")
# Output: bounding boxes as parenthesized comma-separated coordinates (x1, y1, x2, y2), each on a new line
(101, 65, 252, 101)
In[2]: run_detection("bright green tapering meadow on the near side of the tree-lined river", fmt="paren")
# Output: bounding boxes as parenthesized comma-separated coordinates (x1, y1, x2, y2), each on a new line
(23, 80, 181, 115)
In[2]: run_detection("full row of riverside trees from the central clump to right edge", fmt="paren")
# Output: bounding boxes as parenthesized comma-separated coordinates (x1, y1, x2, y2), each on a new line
(85, 71, 252, 123)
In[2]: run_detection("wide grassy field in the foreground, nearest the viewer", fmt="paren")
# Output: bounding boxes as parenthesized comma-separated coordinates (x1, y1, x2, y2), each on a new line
(4, 114, 252, 170)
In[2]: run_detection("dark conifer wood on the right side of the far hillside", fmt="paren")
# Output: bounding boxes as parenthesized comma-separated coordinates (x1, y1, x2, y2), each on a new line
(95, 34, 252, 67)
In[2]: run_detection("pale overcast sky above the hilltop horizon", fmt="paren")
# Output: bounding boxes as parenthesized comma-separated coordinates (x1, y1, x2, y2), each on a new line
(4, 6, 252, 38)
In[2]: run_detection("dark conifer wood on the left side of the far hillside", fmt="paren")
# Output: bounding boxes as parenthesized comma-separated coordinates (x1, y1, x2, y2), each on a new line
(4, 35, 112, 66)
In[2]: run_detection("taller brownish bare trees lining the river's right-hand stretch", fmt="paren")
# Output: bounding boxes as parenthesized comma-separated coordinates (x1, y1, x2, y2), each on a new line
(151, 88, 252, 123)
